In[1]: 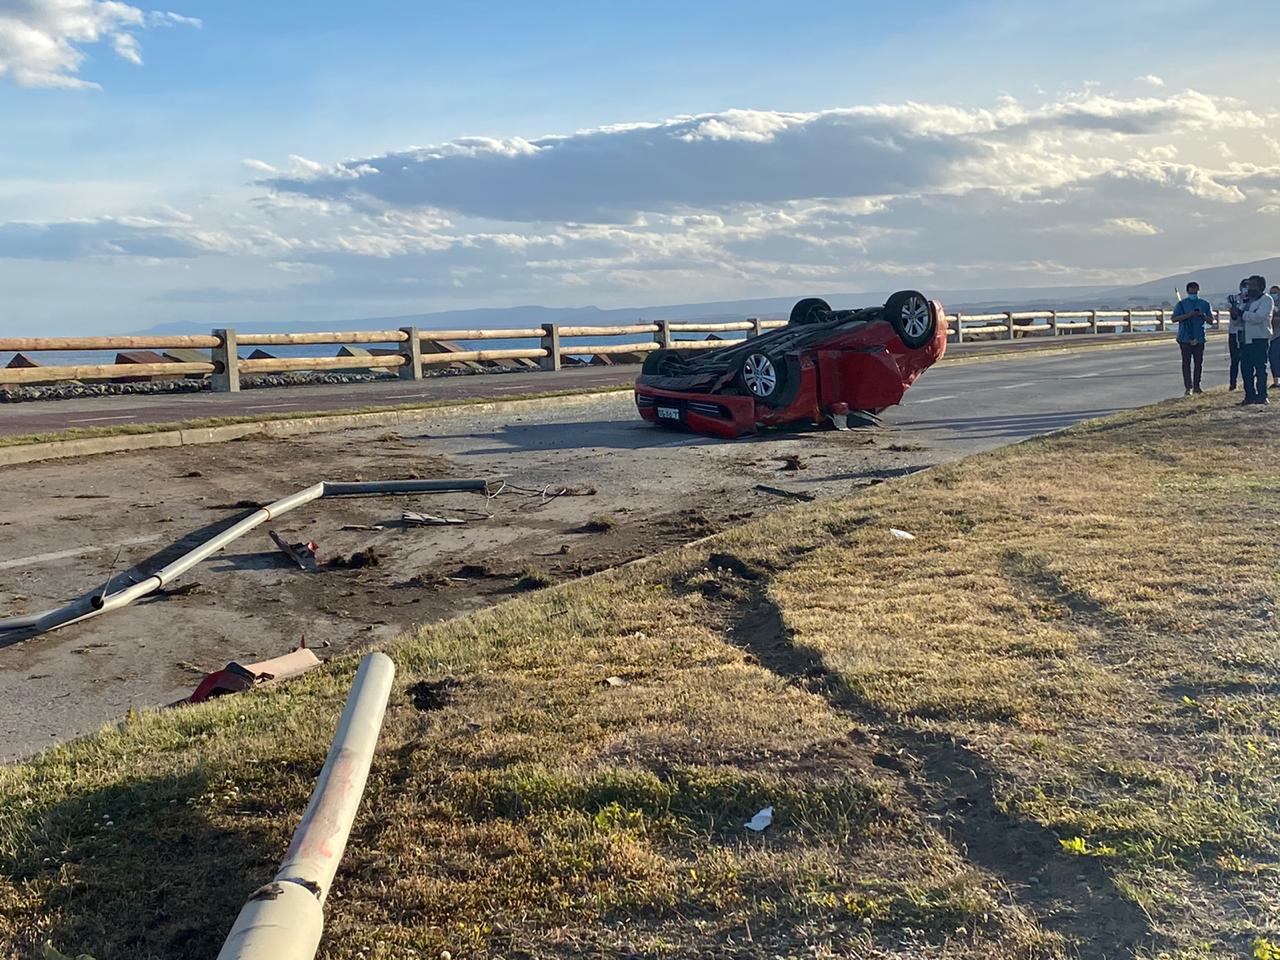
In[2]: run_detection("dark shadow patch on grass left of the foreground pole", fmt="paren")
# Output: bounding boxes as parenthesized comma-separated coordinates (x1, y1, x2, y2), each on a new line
(0, 773, 274, 960)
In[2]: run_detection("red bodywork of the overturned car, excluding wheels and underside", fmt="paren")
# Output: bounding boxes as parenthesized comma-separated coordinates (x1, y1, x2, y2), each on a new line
(635, 301, 947, 439)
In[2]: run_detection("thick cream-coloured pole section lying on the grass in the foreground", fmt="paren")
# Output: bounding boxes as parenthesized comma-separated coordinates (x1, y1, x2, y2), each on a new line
(218, 653, 396, 960)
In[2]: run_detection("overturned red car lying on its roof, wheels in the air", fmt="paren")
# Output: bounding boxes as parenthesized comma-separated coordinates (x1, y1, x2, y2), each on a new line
(635, 291, 947, 438)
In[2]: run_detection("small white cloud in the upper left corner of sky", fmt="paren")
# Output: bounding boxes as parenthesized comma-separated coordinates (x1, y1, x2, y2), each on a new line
(0, 0, 202, 90)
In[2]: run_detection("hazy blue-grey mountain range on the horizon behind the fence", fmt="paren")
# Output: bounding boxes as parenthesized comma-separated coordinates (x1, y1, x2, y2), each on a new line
(135, 257, 1280, 334)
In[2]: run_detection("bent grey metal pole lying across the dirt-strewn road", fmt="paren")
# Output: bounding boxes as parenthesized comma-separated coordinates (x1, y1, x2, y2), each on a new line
(0, 480, 489, 643)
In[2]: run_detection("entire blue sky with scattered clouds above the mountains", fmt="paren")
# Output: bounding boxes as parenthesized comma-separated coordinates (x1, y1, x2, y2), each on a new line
(0, 0, 1280, 335)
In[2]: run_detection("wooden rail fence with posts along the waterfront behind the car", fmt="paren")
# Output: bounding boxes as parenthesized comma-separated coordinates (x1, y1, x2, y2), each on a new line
(0, 310, 1198, 392)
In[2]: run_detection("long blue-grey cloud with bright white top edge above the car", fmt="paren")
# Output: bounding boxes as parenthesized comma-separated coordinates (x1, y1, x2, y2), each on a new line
(255, 91, 1260, 223)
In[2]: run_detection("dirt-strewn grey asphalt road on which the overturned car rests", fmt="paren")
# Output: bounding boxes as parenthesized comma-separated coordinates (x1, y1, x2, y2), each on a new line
(0, 342, 1223, 759)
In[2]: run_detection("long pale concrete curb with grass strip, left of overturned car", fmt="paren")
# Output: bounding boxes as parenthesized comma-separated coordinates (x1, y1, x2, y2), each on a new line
(0, 387, 631, 467)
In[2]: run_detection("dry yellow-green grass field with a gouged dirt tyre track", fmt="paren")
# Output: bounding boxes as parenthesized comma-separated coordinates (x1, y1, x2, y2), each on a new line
(0, 396, 1280, 960)
